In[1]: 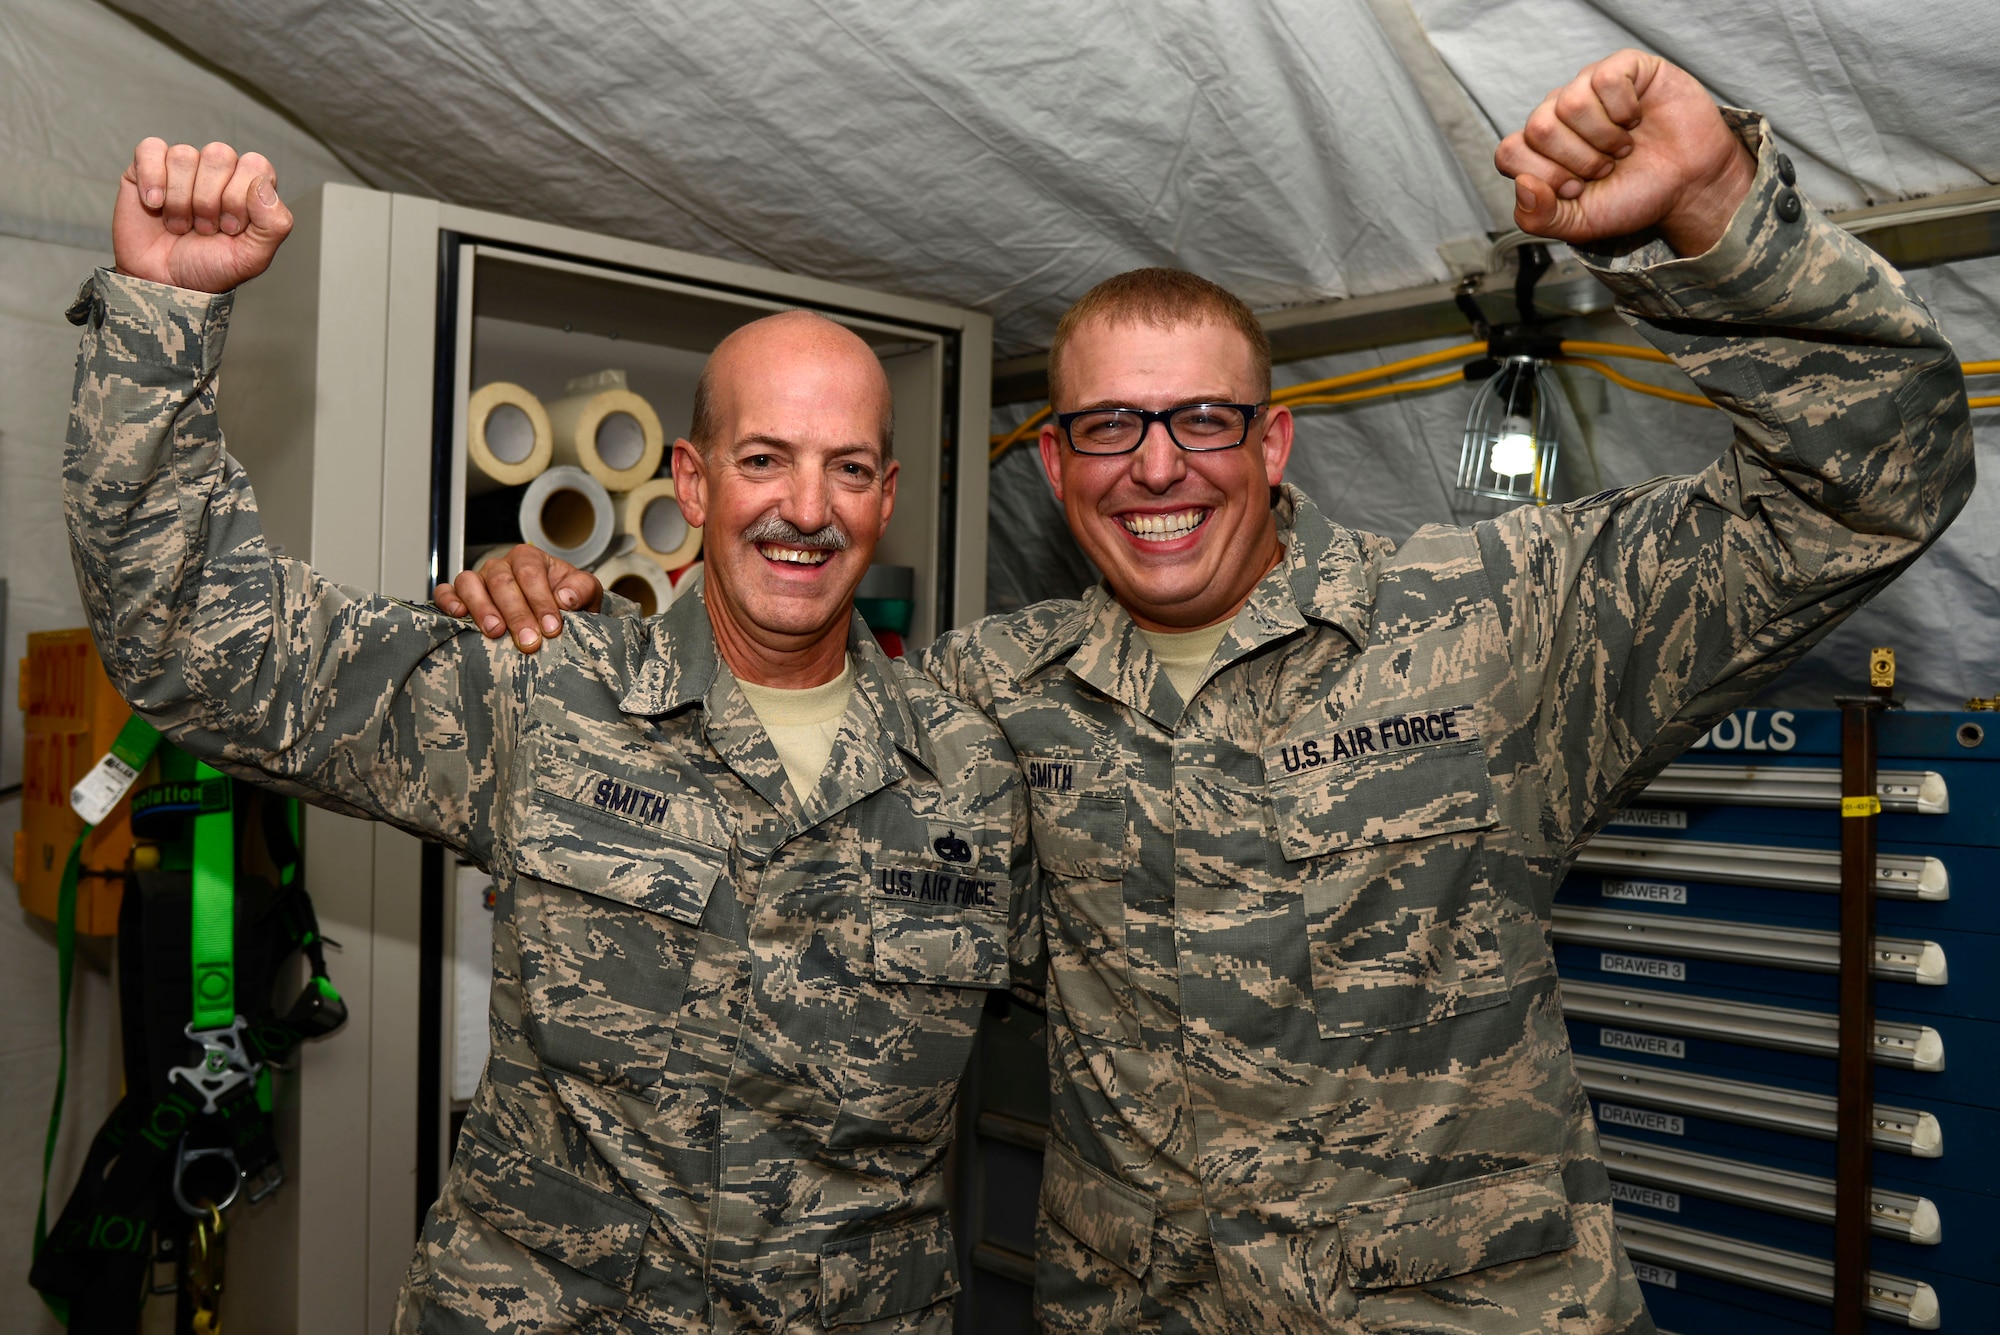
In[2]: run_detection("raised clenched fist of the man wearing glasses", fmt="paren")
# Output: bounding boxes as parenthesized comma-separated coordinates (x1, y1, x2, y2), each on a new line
(1494, 50, 1756, 256)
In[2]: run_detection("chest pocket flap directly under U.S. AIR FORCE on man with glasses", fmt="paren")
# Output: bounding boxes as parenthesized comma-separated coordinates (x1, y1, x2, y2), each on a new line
(1266, 737, 1496, 861)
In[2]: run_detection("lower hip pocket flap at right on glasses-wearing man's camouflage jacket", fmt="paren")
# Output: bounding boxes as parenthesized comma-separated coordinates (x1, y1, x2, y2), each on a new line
(1340, 1163, 1576, 1289)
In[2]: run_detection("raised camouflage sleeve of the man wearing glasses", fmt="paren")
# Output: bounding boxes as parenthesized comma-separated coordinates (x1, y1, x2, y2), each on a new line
(1478, 112, 1972, 853)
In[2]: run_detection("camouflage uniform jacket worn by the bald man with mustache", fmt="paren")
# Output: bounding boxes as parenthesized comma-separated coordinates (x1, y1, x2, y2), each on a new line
(66, 272, 1038, 1331)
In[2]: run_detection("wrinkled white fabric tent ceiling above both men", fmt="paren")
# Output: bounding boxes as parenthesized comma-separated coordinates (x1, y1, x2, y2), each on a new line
(120, 0, 2000, 354)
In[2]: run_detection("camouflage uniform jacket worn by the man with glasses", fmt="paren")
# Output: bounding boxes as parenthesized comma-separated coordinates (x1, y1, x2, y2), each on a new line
(924, 114, 1972, 1335)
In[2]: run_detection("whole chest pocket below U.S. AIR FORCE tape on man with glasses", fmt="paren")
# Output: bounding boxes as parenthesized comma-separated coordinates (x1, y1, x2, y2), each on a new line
(1270, 739, 1508, 1039)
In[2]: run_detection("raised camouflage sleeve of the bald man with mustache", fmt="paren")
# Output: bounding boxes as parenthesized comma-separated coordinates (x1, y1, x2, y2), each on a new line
(64, 270, 516, 861)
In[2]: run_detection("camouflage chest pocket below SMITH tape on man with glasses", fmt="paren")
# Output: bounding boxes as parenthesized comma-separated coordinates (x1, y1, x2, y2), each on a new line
(1020, 755, 1138, 1045)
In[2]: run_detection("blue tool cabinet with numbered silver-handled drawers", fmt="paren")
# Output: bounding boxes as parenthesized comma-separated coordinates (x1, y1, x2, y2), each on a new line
(1554, 709, 2000, 1335)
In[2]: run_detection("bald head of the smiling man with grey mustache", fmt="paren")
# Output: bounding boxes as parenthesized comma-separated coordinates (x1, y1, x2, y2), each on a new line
(674, 312, 896, 685)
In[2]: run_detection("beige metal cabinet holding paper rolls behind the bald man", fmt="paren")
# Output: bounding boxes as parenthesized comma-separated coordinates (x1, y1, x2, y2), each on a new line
(207, 186, 992, 1335)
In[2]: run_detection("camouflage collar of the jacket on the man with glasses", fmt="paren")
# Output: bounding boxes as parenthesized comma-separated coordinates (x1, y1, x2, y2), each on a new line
(1028, 486, 1388, 727)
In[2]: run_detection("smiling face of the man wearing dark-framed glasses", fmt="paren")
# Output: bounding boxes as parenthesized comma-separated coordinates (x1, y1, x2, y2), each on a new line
(1042, 320, 1292, 630)
